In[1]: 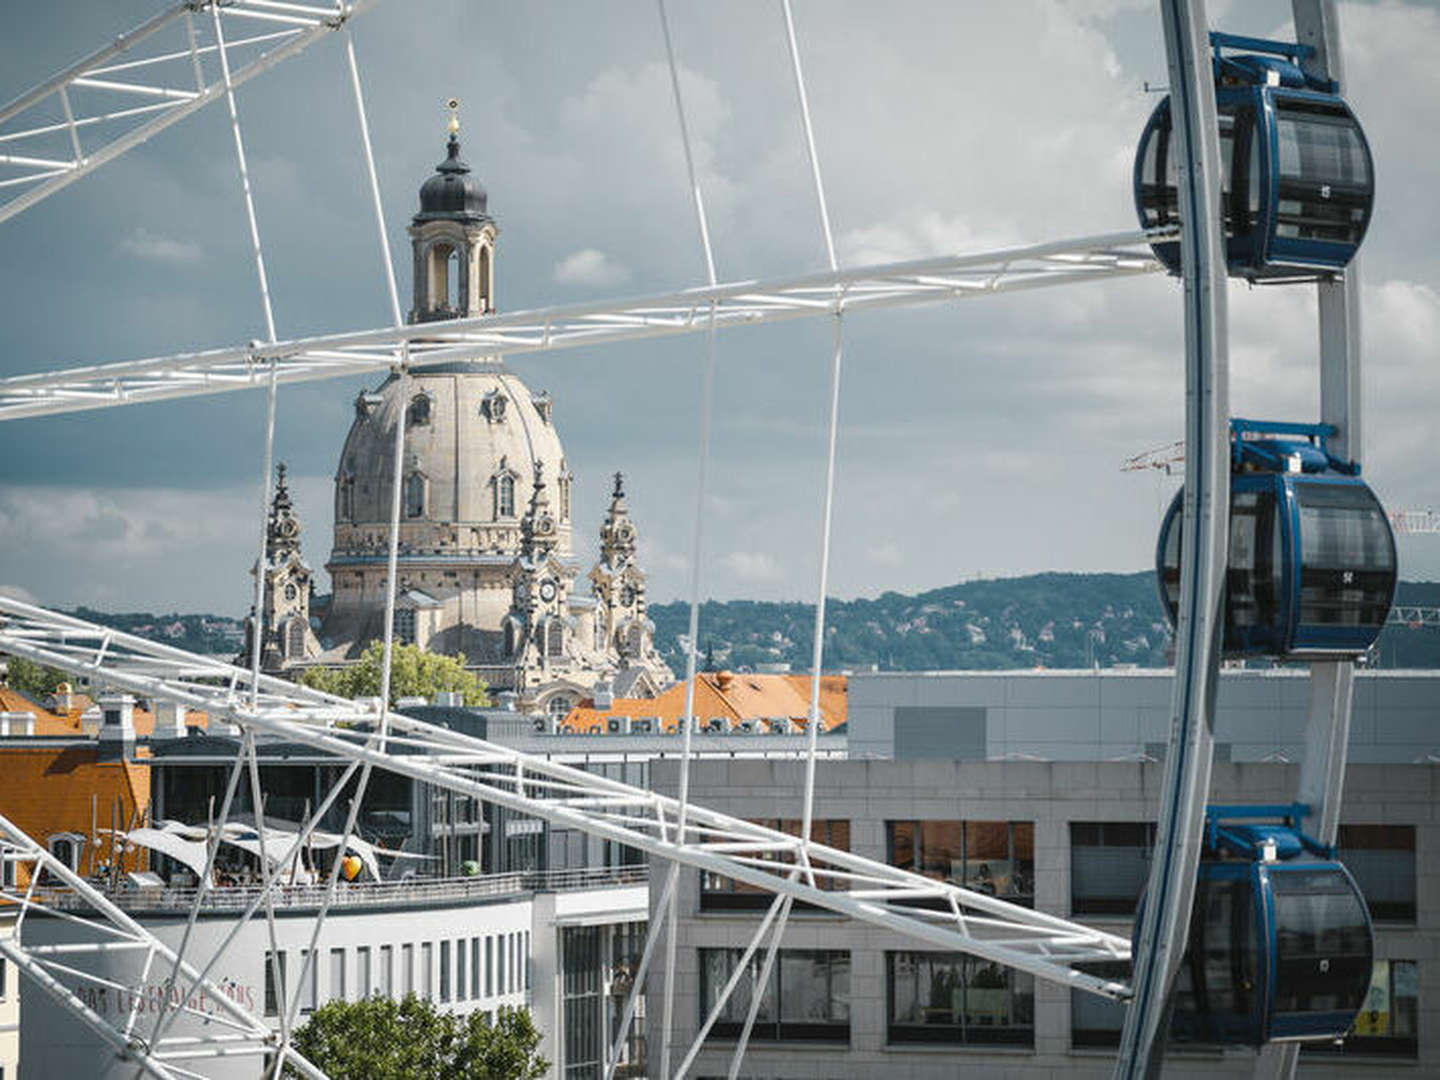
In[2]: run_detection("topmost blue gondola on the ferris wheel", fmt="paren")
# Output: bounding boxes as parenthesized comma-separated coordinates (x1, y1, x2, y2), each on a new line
(1135, 33, 1375, 281)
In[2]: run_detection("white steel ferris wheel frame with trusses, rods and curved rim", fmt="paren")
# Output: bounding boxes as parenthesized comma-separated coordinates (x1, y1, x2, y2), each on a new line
(0, 0, 1358, 1076)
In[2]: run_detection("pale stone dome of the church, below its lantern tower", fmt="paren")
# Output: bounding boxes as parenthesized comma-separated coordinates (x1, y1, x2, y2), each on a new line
(336, 360, 570, 562)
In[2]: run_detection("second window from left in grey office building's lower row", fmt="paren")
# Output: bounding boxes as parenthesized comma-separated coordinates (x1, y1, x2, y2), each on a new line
(886, 952, 1035, 1047)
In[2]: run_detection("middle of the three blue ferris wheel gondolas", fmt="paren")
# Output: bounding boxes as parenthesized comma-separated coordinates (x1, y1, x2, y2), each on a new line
(1155, 419, 1397, 660)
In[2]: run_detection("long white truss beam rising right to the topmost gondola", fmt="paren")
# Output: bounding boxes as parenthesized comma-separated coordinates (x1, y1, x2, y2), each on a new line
(0, 228, 1176, 420)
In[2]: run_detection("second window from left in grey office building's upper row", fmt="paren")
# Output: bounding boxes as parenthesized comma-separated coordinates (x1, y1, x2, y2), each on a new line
(886, 821, 1035, 906)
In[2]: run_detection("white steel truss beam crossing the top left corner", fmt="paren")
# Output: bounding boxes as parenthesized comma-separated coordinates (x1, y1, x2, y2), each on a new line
(0, 0, 373, 222)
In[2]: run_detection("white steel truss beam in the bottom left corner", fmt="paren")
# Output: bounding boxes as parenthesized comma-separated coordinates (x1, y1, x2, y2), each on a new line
(0, 816, 324, 1080)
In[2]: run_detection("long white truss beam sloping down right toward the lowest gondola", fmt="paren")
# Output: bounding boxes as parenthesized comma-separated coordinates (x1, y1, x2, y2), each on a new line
(0, 598, 1130, 1001)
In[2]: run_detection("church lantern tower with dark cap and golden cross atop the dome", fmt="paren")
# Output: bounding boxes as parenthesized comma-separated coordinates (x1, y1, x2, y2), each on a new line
(409, 101, 497, 323)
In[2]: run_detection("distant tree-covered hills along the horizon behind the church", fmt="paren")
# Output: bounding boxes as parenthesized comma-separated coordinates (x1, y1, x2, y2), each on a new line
(2, 570, 1440, 679)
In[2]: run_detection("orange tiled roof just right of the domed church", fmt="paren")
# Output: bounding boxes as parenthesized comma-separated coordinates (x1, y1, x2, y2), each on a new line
(563, 671, 847, 734)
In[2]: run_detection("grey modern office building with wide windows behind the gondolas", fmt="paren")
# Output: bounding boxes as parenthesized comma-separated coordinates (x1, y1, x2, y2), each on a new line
(647, 671, 1440, 1080)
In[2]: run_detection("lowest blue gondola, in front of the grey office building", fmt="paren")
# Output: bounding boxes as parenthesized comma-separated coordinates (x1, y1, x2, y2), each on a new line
(1152, 805, 1375, 1045)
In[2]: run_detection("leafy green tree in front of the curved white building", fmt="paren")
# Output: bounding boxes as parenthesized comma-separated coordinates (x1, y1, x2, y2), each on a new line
(285, 994, 550, 1080)
